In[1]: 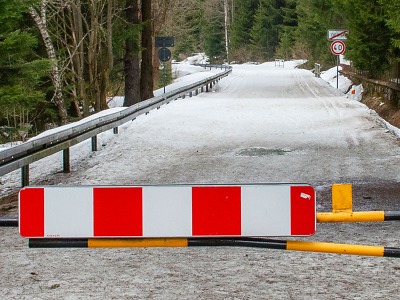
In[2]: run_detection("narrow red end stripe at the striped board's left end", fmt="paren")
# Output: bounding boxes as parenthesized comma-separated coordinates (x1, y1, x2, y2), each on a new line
(19, 188, 44, 237)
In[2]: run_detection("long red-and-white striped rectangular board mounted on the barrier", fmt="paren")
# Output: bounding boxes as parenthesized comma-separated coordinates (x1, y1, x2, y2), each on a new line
(19, 184, 316, 238)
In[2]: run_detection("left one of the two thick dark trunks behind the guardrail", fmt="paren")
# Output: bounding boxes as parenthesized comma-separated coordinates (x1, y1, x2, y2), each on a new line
(124, 0, 140, 106)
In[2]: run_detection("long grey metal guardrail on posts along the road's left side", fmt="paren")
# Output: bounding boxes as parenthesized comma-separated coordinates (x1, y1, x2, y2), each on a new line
(0, 65, 232, 186)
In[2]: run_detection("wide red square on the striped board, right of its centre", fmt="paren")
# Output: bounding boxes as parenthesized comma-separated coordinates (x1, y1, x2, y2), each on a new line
(192, 186, 241, 236)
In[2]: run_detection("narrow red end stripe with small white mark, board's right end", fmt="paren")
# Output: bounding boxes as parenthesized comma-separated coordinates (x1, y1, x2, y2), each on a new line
(290, 186, 316, 235)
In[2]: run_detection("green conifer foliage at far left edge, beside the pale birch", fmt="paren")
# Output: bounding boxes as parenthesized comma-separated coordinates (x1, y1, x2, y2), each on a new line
(0, 0, 50, 133)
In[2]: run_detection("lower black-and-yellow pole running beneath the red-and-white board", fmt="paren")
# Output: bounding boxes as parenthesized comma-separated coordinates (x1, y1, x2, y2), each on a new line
(29, 238, 400, 257)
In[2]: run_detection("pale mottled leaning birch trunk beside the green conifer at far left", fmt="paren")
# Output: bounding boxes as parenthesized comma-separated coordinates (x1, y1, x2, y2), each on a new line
(29, 0, 68, 124)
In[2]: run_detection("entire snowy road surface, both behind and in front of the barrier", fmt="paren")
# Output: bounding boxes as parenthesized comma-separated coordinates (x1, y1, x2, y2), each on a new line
(0, 63, 400, 299)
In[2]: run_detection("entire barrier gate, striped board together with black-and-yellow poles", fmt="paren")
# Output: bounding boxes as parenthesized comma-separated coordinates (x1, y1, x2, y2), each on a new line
(5, 184, 400, 257)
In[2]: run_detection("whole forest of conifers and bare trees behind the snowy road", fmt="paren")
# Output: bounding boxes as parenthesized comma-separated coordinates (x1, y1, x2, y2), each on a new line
(0, 0, 400, 142)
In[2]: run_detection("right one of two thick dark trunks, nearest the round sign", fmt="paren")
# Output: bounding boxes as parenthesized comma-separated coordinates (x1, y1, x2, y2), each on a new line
(140, 0, 154, 100)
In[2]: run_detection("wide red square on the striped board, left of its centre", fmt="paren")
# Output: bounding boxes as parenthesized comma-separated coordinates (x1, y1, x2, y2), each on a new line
(93, 187, 143, 237)
